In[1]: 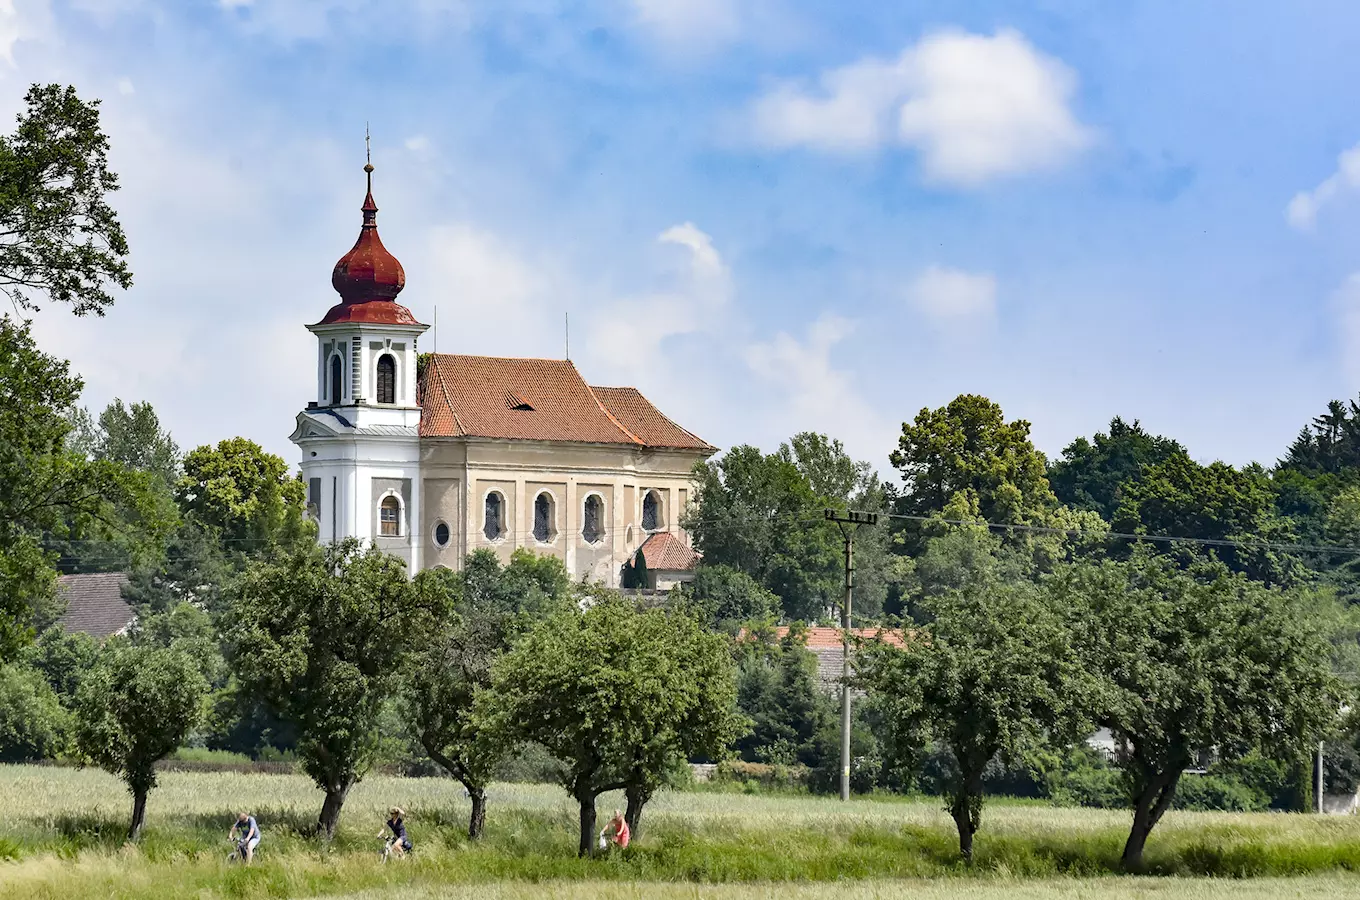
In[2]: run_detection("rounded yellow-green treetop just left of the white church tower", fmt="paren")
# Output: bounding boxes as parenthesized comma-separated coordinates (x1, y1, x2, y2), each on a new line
(175, 438, 305, 552)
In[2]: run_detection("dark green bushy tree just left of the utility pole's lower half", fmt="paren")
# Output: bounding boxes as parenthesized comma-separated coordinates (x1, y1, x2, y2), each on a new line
(734, 623, 840, 767)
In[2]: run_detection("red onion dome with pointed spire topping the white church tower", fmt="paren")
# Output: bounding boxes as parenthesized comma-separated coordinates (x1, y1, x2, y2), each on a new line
(318, 163, 420, 325)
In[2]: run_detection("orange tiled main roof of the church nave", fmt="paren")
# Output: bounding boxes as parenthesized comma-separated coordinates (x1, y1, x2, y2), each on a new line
(420, 353, 717, 453)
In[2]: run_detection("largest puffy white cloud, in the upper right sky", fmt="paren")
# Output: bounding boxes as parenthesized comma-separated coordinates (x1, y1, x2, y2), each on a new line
(751, 30, 1093, 186)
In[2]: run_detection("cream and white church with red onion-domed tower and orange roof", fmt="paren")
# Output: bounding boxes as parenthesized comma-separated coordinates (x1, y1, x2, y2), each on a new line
(291, 163, 717, 590)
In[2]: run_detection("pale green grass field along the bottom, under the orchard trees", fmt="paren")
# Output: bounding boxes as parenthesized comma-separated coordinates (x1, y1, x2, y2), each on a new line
(0, 765, 1360, 900)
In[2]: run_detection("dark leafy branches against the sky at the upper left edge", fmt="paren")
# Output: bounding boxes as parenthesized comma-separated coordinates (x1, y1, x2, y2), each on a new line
(0, 84, 132, 315)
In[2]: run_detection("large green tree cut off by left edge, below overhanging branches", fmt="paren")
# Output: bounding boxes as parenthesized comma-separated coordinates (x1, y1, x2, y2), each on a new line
(0, 316, 167, 661)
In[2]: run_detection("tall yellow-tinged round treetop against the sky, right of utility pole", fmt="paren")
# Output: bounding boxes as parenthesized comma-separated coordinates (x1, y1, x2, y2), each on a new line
(889, 394, 1058, 525)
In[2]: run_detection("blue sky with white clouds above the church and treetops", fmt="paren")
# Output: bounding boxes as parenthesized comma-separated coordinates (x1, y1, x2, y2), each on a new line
(0, 0, 1360, 478)
